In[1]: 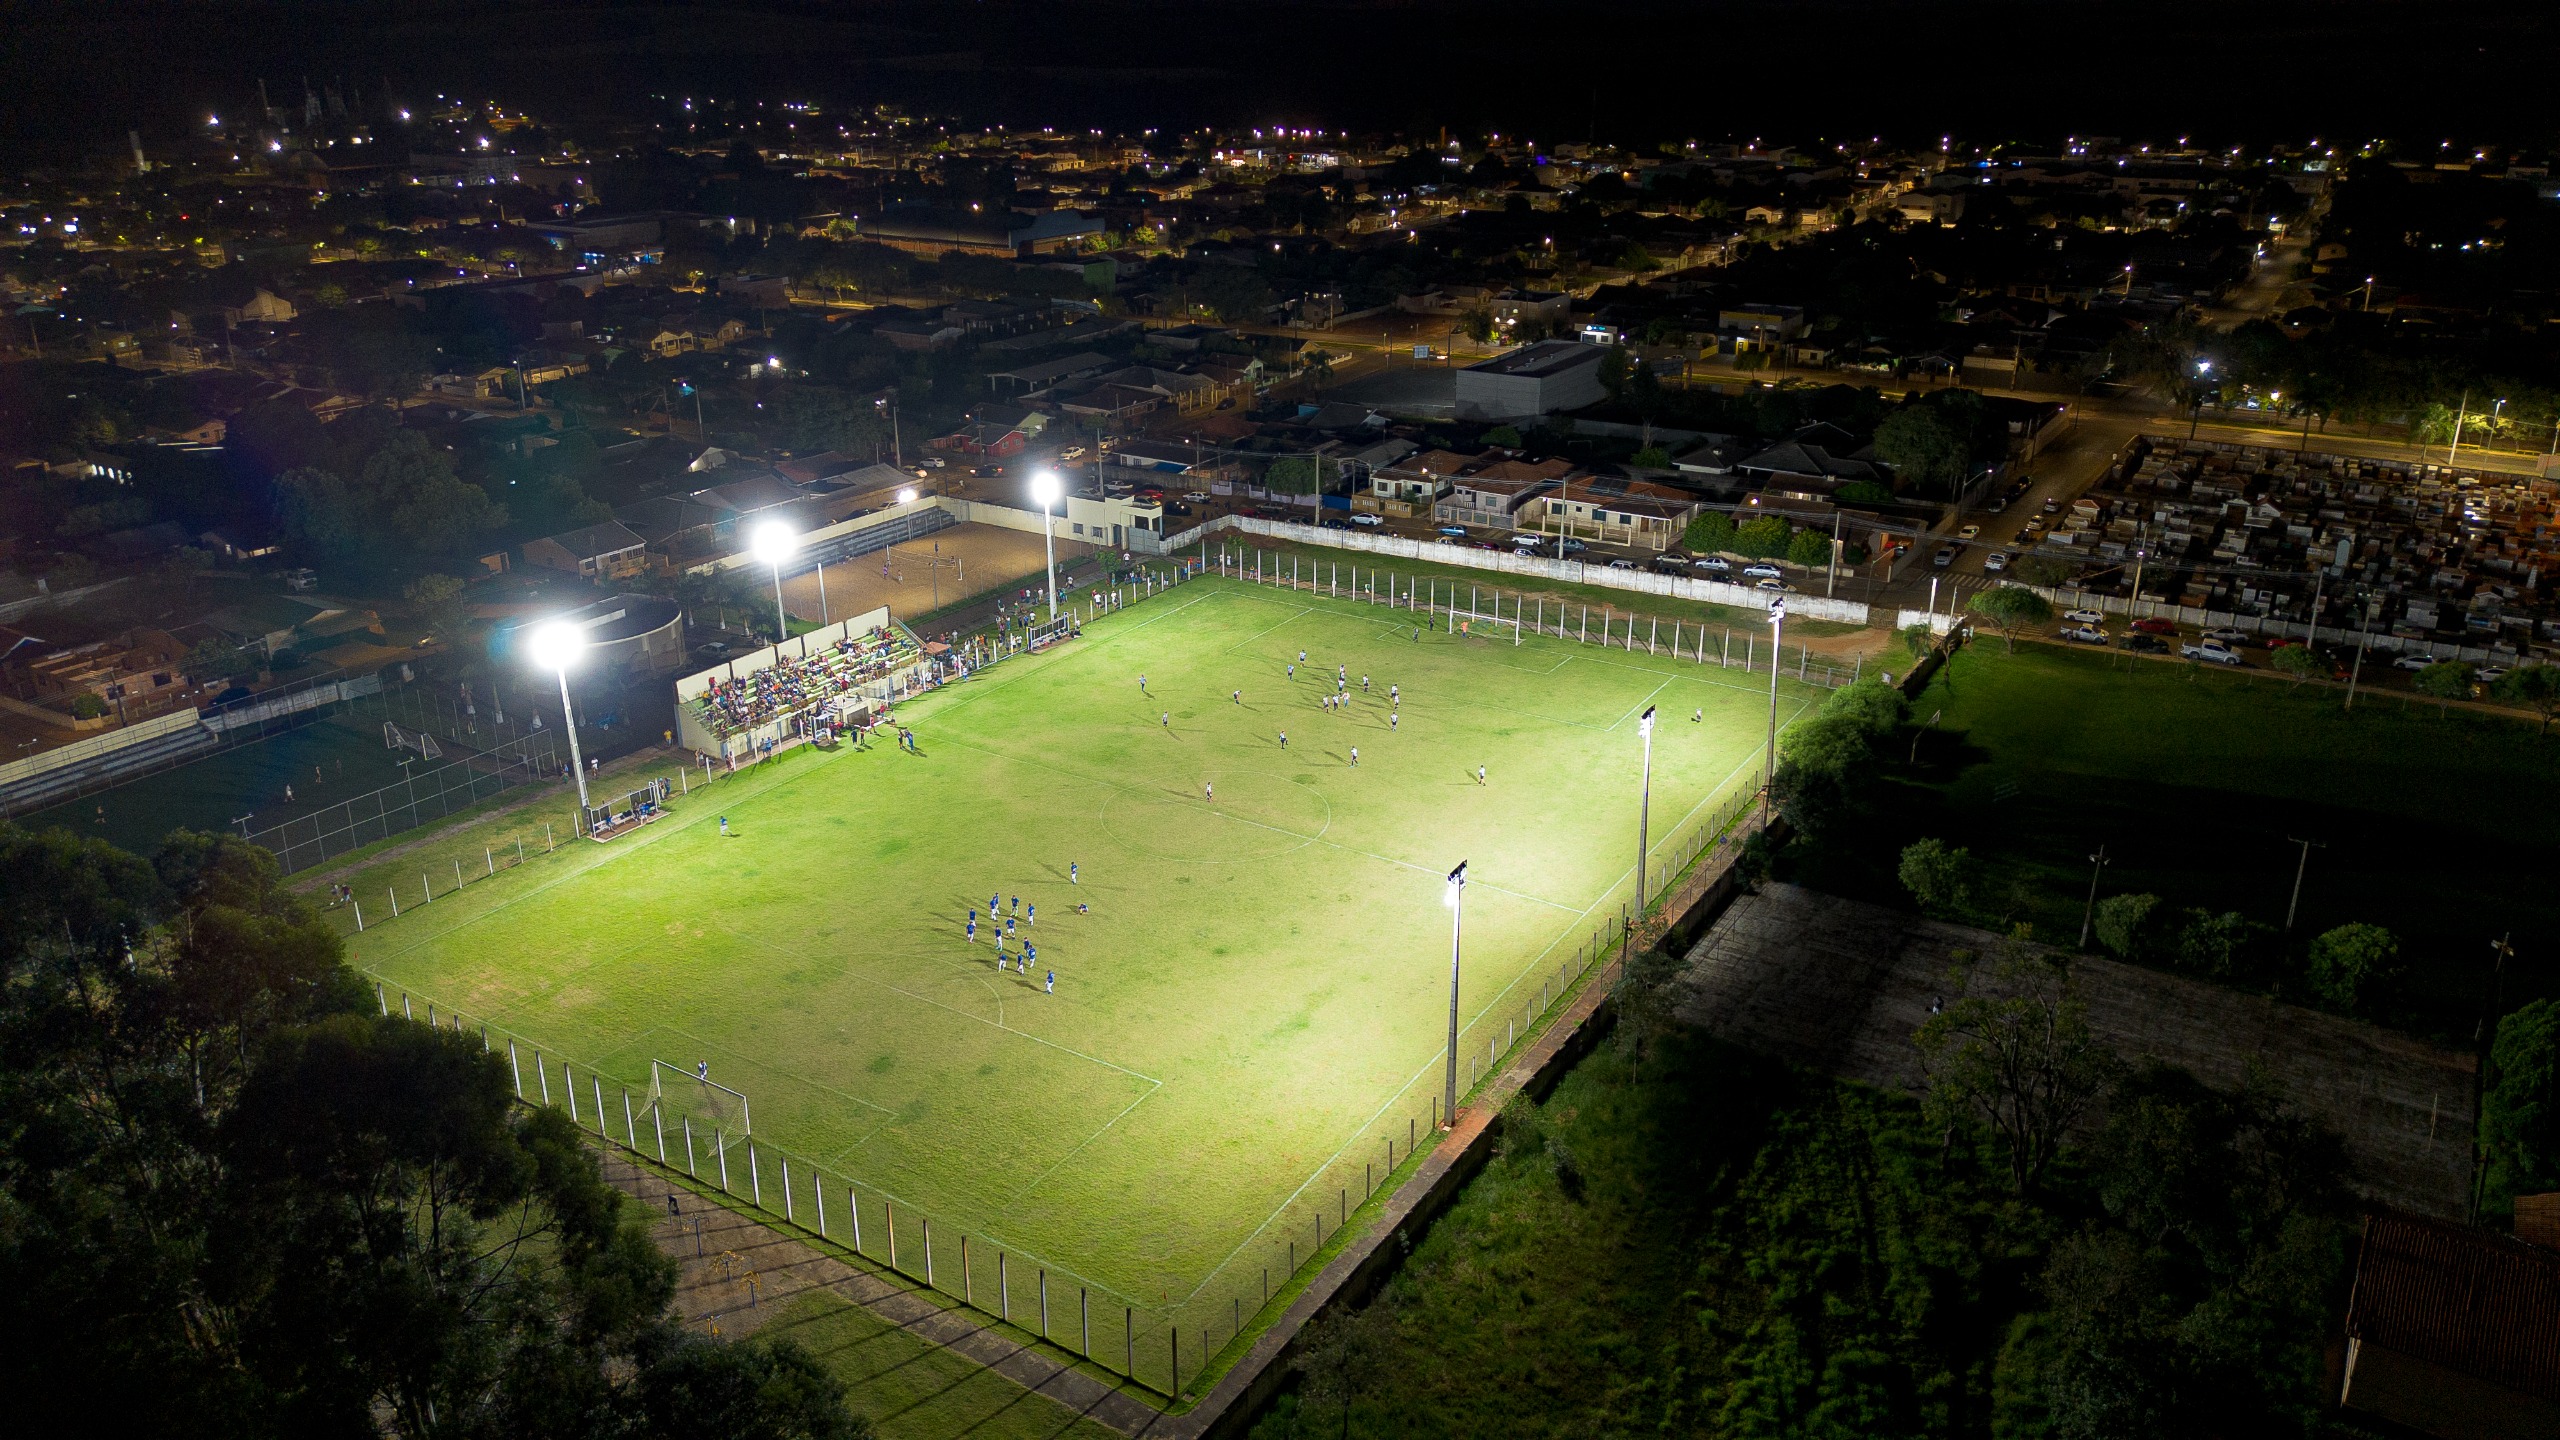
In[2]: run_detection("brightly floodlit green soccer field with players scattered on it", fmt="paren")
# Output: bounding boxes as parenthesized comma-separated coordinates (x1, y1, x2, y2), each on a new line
(351, 579, 1820, 1379)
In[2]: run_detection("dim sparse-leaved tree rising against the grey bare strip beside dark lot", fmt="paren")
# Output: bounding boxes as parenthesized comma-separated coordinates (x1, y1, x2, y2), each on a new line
(1915, 928, 2117, 1194)
